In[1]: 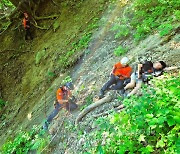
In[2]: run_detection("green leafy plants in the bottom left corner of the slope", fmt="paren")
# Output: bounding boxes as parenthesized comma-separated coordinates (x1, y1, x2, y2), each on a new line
(0, 126, 49, 154)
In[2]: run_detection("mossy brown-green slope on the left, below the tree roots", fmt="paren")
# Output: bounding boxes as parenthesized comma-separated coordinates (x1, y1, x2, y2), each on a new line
(0, 0, 112, 147)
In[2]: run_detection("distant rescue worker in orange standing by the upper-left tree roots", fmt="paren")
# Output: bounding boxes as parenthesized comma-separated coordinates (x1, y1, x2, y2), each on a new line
(23, 12, 33, 40)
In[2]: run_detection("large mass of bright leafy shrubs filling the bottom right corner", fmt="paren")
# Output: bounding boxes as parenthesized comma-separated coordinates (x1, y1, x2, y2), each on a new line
(87, 75, 180, 154)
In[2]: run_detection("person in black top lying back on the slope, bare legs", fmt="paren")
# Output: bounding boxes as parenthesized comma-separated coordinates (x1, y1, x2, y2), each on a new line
(121, 61, 166, 97)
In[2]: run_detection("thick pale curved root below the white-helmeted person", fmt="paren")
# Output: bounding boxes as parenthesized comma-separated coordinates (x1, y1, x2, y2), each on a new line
(75, 94, 113, 126)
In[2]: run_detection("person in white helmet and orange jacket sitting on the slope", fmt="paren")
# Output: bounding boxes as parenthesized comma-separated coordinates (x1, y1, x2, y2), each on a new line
(99, 57, 132, 99)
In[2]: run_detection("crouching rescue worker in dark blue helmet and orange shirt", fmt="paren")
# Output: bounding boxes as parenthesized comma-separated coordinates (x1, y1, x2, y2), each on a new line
(43, 82, 77, 130)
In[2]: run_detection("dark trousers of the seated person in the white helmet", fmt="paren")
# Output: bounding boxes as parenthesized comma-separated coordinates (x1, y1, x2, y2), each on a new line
(101, 74, 124, 91)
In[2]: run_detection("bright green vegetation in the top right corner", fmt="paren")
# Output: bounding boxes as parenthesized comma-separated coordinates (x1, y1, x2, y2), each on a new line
(112, 0, 180, 41)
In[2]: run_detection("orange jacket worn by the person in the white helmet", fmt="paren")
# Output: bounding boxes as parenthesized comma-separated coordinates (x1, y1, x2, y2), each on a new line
(112, 62, 132, 80)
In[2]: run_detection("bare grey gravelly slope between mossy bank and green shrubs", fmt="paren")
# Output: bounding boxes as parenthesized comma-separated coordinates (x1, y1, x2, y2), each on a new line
(40, 0, 180, 154)
